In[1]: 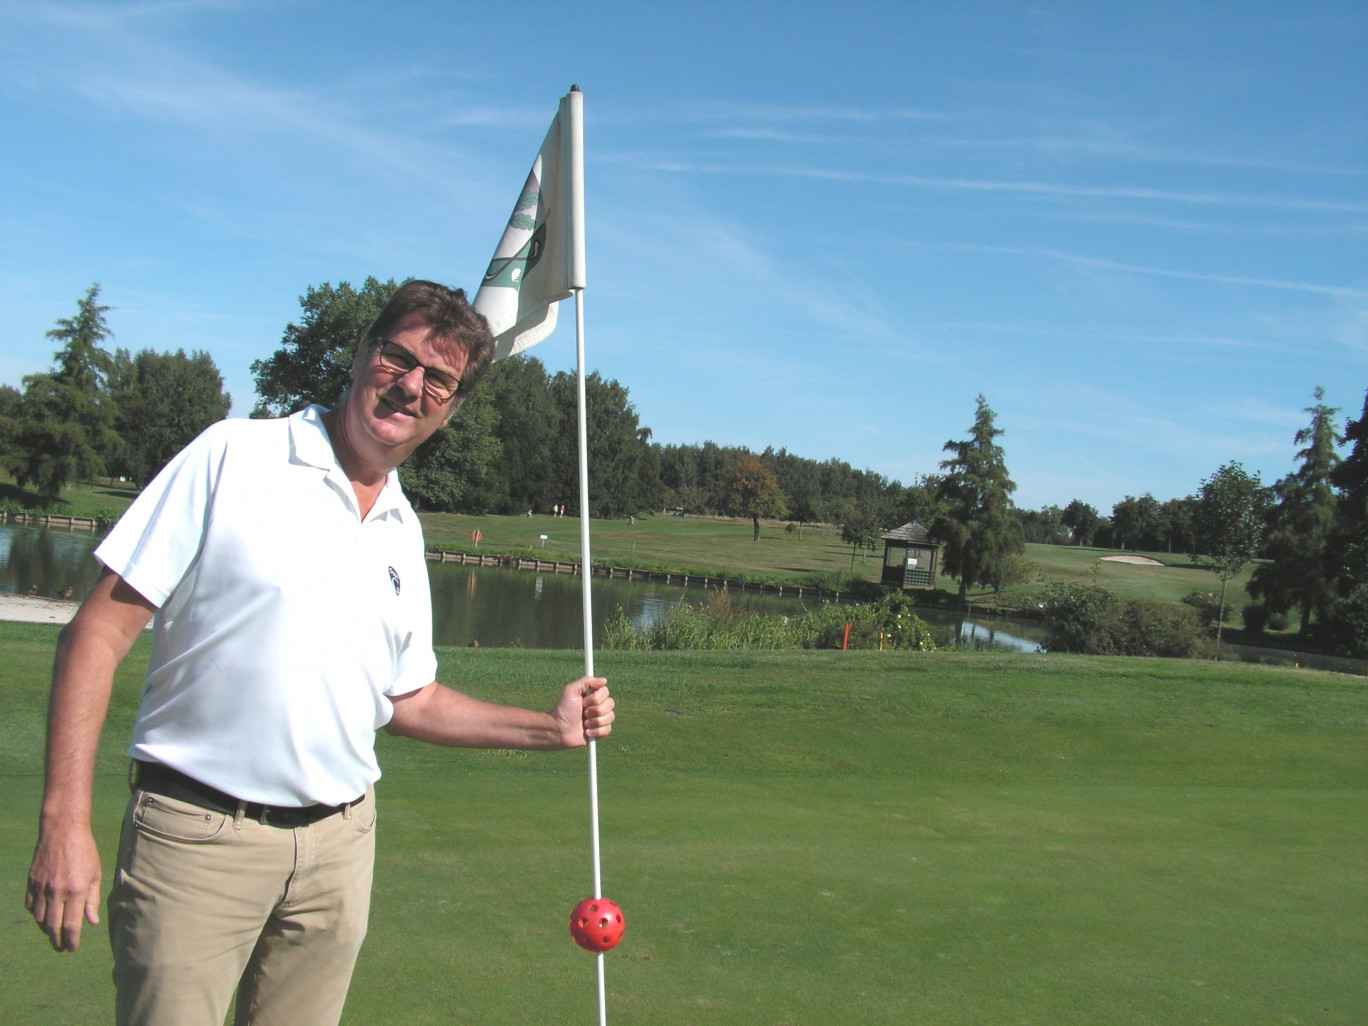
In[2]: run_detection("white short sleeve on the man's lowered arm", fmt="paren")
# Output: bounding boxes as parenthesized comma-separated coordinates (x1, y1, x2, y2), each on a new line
(94, 421, 227, 607)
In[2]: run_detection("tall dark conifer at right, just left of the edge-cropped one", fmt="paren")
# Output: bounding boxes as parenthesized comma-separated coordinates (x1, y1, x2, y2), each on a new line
(1248, 387, 1343, 635)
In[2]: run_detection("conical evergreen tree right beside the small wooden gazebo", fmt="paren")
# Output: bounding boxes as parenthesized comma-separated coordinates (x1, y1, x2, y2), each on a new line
(930, 395, 1025, 605)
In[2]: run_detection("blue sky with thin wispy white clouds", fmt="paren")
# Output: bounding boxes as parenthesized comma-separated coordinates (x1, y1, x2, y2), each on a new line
(0, 0, 1368, 513)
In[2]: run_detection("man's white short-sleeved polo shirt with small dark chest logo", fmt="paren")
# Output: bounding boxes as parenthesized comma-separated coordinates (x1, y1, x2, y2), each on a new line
(96, 406, 436, 806)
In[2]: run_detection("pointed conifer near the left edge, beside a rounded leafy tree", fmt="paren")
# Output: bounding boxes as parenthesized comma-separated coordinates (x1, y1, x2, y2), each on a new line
(5, 283, 118, 499)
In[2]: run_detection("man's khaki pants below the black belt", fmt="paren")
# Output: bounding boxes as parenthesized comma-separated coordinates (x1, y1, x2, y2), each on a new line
(109, 791, 375, 1026)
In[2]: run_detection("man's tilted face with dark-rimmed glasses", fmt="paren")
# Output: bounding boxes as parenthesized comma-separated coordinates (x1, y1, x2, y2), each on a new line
(346, 316, 465, 466)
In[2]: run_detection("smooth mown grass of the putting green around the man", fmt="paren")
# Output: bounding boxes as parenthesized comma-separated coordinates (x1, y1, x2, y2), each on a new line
(0, 625, 1368, 1026)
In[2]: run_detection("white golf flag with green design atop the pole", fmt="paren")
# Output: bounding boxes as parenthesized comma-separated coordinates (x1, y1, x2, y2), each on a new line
(475, 86, 584, 360)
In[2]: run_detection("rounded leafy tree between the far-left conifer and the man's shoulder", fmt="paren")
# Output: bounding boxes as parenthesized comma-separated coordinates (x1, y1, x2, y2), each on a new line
(108, 349, 233, 484)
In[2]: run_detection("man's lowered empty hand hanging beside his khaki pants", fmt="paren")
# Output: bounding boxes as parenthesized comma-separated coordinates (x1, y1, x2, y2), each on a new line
(23, 824, 100, 951)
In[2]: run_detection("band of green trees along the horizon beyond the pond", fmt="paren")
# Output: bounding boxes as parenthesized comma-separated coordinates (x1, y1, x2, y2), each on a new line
(0, 278, 1368, 659)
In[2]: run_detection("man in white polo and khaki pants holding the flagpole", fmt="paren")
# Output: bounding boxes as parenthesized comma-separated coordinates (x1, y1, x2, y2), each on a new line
(25, 282, 614, 1026)
